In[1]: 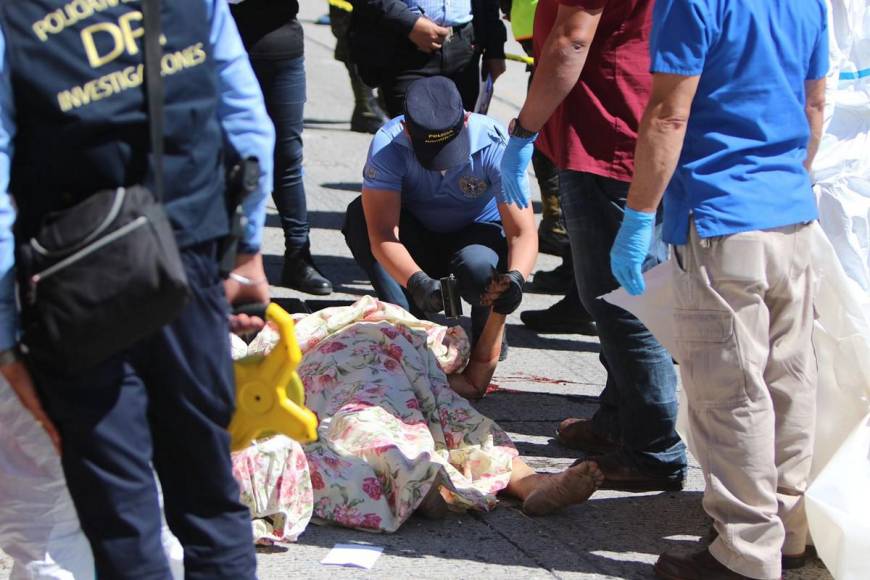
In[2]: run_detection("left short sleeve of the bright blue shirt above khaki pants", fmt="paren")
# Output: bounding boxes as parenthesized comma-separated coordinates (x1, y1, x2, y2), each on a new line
(649, 0, 713, 77)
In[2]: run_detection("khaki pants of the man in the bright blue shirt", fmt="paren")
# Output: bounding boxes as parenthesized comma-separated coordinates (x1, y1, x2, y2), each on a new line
(674, 224, 816, 578)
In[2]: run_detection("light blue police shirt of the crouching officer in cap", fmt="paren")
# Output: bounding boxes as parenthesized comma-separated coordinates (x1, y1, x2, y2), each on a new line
(363, 114, 507, 233)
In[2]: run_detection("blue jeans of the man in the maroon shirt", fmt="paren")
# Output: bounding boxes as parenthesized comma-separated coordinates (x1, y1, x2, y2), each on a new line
(559, 171, 686, 478)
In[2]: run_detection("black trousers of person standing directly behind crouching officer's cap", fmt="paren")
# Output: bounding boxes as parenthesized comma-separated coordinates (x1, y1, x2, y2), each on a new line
(378, 22, 480, 117)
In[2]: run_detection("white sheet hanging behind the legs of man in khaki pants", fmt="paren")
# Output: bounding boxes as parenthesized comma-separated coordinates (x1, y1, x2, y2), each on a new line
(602, 224, 870, 580)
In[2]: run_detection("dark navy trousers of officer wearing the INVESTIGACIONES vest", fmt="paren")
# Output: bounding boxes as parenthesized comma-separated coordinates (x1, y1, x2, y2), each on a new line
(31, 243, 256, 580)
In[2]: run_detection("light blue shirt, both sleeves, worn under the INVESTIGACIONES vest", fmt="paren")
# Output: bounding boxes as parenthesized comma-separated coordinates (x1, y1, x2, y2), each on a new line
(0, 0, 275, 350)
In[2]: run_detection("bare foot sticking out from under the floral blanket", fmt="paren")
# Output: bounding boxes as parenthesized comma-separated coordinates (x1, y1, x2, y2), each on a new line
(523, 461, 604, 516)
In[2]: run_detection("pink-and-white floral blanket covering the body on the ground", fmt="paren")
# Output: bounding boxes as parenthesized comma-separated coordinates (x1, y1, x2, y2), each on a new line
(233, 297, 517, 540)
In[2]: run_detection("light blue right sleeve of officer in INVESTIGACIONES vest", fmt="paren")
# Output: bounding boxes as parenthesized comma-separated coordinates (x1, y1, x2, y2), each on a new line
(205, 0, 275, 254)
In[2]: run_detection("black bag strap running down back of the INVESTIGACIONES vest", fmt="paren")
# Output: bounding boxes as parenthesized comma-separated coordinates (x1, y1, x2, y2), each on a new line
(142, 0, 163, 202)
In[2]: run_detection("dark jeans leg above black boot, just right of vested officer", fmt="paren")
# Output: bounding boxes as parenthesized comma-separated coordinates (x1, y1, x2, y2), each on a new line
(251, 56, 309, 249)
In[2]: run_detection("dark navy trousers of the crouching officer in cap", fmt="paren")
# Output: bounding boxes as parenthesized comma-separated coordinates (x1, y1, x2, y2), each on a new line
(342, 197, 507, 342)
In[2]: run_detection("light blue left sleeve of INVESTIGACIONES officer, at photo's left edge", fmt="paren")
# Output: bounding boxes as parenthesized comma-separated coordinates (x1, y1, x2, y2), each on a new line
(0, 30, 18, 350)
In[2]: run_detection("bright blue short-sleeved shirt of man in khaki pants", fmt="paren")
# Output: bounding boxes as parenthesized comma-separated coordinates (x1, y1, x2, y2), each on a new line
(650, 0, 828, 244)
